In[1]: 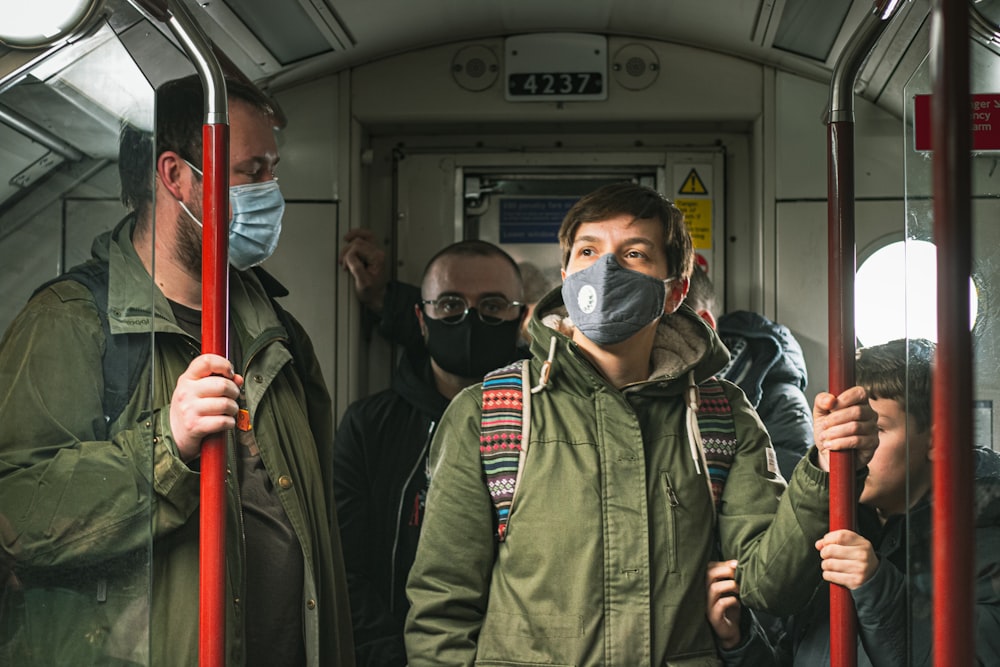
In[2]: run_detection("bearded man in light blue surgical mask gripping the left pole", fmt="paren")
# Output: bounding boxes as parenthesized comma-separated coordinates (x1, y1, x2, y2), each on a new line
(0, 76, 354, 667)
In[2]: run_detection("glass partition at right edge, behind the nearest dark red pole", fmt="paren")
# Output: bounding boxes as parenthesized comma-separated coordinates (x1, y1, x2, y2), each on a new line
(900, 18, 1000, 664)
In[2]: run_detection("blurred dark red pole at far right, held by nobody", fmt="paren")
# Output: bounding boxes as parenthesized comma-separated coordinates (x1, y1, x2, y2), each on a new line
(931, 0, 975, 667)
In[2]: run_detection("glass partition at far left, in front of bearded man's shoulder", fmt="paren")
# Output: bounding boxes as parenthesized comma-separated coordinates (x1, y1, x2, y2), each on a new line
(0, 16, 157, 667)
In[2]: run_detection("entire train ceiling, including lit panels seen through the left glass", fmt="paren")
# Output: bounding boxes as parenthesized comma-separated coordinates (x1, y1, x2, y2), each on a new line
(0, 0, 993, 224)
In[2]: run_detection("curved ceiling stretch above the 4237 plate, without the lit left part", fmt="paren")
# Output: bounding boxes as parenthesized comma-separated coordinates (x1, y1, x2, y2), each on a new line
(240, 0, 929, 112)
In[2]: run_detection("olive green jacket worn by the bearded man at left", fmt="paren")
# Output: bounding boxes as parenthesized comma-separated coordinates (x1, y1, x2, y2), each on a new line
(0, 219, 354, 667)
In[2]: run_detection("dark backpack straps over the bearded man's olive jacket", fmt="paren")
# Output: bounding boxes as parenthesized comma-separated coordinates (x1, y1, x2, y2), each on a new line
(32, 259, 300, 424)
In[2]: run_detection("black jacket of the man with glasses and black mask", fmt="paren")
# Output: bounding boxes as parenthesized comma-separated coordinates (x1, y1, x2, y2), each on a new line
(333, 348, 448, 667)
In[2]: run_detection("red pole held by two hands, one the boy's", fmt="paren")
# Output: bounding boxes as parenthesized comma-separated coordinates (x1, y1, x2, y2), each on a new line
(827, 0, 899, 667)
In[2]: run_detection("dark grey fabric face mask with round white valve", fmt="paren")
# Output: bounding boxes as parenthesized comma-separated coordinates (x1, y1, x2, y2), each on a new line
(562, 253, 670, 345)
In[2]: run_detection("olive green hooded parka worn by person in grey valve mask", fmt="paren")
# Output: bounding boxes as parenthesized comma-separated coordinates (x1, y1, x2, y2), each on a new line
(406, 289, 844, 667)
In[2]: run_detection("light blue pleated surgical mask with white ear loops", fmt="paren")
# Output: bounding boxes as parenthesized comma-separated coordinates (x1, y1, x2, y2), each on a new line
(178, 160, 285, 271)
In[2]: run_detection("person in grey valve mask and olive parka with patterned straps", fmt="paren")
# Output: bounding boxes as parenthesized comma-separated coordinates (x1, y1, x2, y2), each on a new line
(406, 183, 878, 667)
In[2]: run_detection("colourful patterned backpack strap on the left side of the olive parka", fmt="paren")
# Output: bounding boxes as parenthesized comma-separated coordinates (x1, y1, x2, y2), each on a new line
(479, 360, 530, 542)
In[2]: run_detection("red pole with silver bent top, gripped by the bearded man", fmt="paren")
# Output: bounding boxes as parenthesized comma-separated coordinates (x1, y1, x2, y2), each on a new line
(163, 0, 229, 667)
